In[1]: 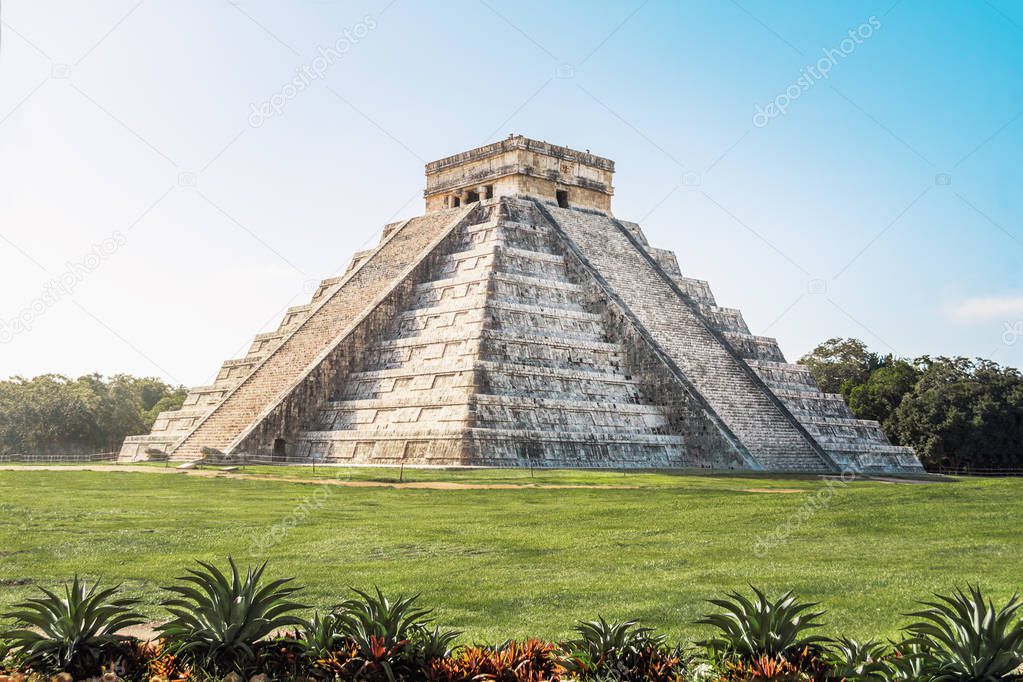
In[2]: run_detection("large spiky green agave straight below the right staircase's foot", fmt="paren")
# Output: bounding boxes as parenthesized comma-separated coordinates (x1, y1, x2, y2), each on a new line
(697, 585, 829, 660)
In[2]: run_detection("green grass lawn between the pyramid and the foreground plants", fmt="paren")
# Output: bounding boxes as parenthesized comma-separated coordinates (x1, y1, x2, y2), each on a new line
(0, 466, 1023, 641)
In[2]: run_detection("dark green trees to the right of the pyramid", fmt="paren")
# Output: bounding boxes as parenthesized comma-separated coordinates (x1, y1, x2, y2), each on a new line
(799, 338, 1023, 471)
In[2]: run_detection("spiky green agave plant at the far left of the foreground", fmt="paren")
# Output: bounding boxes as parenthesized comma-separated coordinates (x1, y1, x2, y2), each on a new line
(0, 576, 143, 678)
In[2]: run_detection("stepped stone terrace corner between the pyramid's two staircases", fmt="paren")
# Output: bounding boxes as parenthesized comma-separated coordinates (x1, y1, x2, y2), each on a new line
(296, 199, 686, 466)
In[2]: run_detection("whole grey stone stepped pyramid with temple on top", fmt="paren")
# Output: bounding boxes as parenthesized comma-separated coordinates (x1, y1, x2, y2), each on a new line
(121, 137, 923, 472)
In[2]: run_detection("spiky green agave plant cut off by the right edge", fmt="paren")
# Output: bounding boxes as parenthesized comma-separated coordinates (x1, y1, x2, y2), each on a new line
(903, 586, 1023, 680)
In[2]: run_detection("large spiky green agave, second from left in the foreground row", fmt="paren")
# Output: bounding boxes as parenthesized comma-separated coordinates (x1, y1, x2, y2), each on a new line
(158, 557, 305, 671)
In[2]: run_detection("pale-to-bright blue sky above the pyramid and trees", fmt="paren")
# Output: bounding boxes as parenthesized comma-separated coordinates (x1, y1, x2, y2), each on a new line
(0, 0, 1023, 384)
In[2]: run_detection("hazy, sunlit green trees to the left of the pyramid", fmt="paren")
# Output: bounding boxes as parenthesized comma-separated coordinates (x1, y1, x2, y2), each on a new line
(0, 374, 187, 455)
